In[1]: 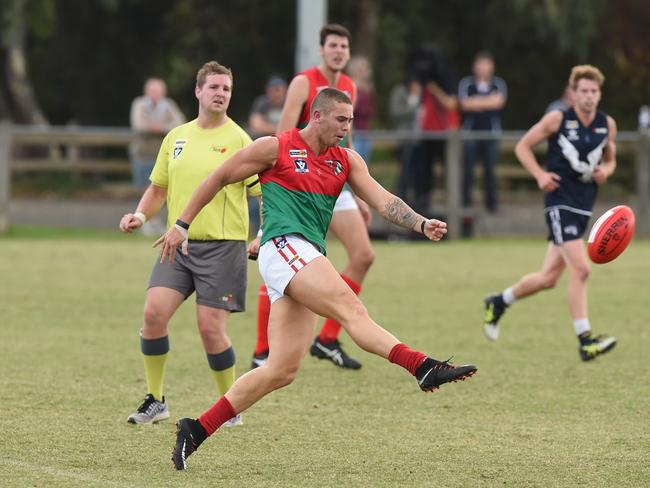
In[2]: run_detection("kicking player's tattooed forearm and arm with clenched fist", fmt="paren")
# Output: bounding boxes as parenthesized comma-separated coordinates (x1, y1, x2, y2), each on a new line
(347, 149, 447, 241)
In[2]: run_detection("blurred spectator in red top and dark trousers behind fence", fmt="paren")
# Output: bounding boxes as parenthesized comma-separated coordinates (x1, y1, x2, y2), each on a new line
(408, 43, 460, 214)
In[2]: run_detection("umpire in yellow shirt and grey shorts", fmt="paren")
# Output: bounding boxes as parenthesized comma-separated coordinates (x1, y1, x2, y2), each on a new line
(120, 61, 261, 425)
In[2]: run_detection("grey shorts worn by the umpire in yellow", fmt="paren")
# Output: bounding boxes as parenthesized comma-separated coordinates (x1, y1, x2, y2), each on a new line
(147, 240, 247, 312)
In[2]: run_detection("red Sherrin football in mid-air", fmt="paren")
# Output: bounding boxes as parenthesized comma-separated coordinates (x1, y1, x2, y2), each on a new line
(587, 205, 634, 264)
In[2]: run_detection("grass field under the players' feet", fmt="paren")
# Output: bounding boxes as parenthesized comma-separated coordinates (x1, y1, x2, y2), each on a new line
(0, 232, 650, 488)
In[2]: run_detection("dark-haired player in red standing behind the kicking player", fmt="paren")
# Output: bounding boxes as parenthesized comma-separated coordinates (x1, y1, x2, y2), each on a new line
(252, 24, 374, 369)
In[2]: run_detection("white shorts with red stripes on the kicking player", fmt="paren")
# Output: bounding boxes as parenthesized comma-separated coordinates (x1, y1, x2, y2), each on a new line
(258, 234, 323, 303)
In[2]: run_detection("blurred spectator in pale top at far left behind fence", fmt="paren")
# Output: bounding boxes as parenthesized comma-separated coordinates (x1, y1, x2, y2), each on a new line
(129, 78, 185, 188)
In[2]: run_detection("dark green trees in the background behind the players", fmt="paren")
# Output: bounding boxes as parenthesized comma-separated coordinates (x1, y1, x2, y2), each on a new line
(8, 0, 650, 130)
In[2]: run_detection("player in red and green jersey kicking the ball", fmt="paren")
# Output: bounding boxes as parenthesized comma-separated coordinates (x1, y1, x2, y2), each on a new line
(156, 88, 476, 470)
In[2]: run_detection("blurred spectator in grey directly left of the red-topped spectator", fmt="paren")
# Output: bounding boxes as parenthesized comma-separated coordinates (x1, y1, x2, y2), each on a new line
(388, 81, 422, 201)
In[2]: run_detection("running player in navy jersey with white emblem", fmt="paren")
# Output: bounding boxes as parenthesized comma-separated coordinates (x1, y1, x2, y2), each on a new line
(485, 65, 616, 361)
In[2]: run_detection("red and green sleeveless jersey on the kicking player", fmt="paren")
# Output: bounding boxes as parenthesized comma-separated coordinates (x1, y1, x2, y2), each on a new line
(259, 129, 350, 254)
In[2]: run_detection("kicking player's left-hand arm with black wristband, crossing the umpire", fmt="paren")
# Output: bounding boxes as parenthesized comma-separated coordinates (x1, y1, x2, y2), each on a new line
(154, 136, 278, 263)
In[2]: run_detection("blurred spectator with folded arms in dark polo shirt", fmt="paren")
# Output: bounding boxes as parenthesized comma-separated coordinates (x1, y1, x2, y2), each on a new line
(458, 51, 508, 212)
